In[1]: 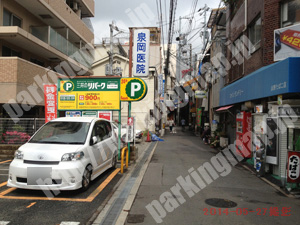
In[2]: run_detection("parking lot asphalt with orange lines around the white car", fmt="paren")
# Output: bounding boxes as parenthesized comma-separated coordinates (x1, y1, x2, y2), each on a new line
(0, 161, 121, 225)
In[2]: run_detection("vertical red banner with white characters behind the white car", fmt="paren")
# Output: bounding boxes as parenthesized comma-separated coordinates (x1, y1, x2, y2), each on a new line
(44, 84, 57, 123)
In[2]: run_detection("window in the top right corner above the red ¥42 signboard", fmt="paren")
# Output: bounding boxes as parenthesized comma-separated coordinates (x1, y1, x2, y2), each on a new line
(281, 1, 300, 27)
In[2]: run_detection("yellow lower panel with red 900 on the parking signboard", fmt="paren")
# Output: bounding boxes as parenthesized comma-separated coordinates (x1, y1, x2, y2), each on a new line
(58, 91, 120, 110)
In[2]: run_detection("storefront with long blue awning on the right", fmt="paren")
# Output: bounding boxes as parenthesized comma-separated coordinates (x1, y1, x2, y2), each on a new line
(220, 58, 300, 184)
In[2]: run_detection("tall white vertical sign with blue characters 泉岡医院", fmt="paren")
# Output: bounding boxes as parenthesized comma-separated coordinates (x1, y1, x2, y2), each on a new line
(133, 29, 150, 77)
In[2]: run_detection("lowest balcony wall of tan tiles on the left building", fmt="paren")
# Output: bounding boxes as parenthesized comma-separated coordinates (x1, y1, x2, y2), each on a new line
(0, 57, 62, 105)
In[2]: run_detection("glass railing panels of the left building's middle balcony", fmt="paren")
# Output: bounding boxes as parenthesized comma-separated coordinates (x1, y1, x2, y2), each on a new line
(31, 26, 93, 69)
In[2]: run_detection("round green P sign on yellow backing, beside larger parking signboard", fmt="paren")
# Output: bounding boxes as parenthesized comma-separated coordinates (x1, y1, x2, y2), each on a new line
(121, 77, 147, 102)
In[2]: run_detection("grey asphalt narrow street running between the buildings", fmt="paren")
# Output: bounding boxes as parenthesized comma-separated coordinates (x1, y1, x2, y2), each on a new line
(126, 128, 300, 225)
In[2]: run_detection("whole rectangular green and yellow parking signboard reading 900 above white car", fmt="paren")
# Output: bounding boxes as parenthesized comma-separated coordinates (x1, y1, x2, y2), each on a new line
(58, 78, 120, 110)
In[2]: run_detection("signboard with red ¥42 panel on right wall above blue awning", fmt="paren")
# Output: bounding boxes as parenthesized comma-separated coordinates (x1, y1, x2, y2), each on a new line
(274, 24, 300, 61)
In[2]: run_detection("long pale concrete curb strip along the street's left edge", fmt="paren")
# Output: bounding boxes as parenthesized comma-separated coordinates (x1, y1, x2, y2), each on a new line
(116, 142, 158, 225)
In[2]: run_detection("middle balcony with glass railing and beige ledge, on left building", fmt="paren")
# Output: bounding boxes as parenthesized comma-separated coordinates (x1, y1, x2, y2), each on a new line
(0, 26, 93, 74)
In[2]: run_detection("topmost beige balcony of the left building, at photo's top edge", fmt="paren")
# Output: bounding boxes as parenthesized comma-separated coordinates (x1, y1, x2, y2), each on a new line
(16, 0, 94, 46)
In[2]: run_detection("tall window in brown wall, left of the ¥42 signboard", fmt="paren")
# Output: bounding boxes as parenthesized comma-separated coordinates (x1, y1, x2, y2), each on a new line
(248, 17, 261, 54)
